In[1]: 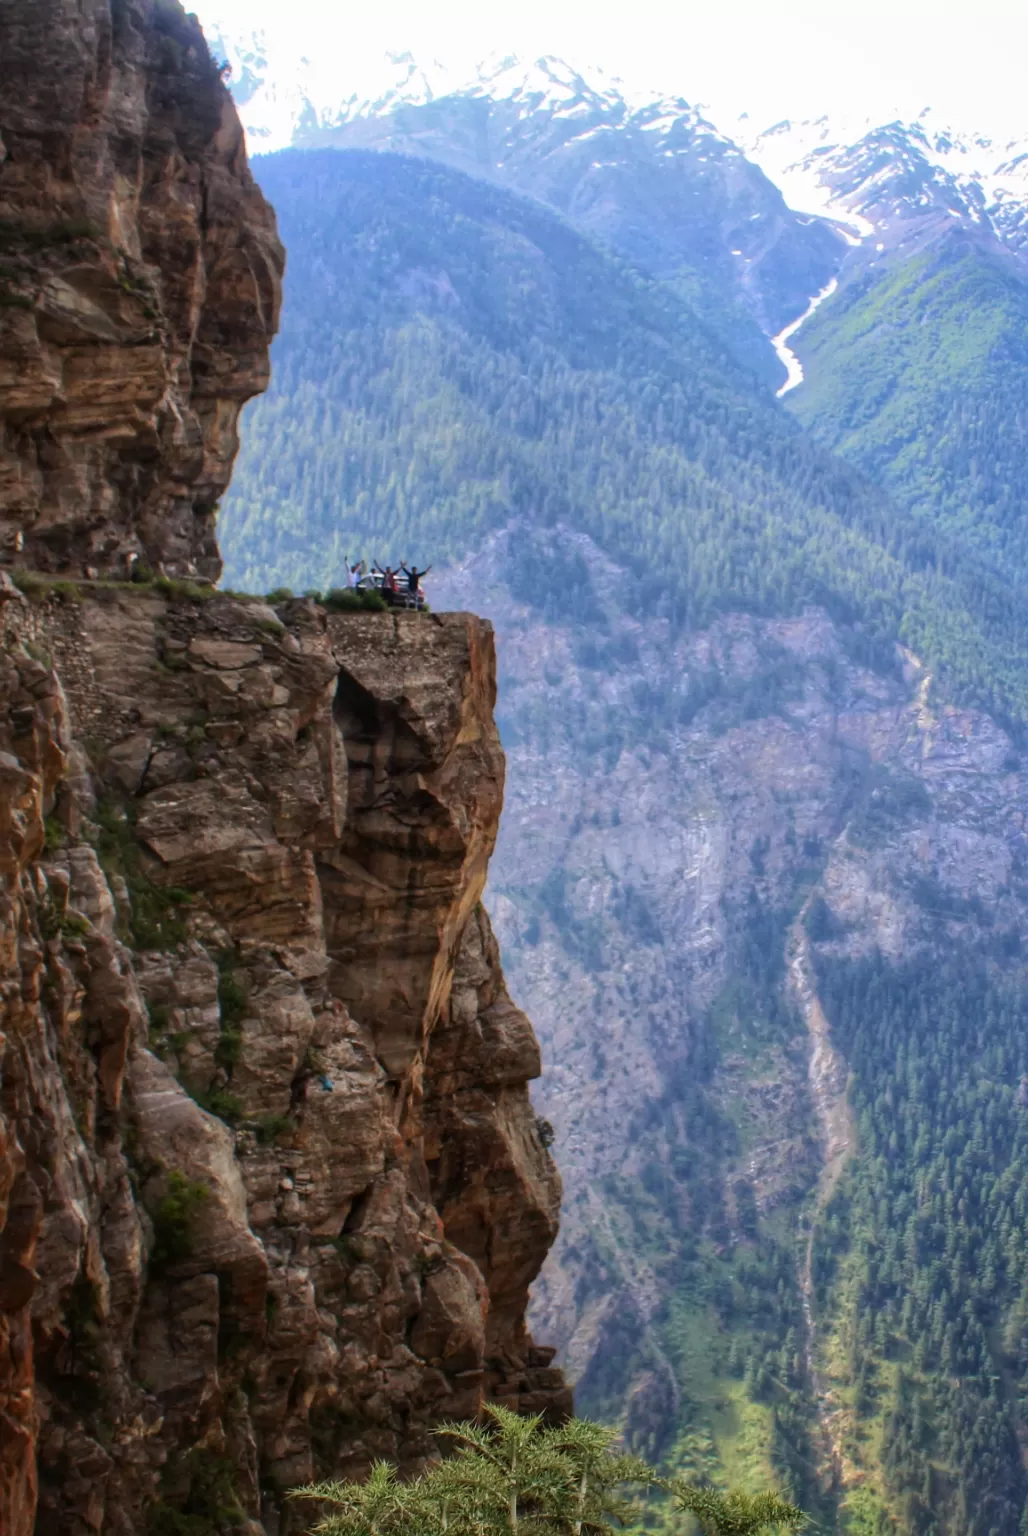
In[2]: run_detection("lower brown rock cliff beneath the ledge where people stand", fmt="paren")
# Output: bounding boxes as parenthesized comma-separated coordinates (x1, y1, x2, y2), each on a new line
(0, 585, 569, 1536)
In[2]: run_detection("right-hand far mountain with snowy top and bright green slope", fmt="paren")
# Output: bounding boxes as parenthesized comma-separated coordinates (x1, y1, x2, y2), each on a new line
(737, 112, 1028, 586)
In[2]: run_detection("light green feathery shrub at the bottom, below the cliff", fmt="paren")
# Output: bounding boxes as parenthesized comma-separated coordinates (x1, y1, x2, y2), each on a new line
(292, 1405, 805, 1536)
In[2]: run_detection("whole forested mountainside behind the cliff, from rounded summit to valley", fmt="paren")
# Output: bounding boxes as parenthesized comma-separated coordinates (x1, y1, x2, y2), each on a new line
(221, 151, 1028, 1536)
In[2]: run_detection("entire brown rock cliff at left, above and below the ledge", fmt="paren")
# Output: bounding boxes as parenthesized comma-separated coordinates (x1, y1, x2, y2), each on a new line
(0, 0, 570, 1536)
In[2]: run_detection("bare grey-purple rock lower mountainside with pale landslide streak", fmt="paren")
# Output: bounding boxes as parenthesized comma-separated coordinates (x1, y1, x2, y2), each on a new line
(438, 528, 1028, 1530)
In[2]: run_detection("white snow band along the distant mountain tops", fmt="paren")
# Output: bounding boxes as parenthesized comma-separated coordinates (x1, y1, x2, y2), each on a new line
(203, 20, 1028, 261)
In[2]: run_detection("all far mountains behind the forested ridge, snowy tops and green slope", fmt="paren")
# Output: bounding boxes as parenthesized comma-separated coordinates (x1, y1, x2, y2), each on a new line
(208, 28, 1028, 586)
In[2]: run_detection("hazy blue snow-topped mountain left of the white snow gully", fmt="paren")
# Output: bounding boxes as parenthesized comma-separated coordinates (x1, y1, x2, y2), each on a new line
(202, 38, 847, 387)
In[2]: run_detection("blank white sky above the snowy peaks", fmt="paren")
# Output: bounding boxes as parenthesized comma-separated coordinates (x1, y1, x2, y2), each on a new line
(186, 0, 1028, 137)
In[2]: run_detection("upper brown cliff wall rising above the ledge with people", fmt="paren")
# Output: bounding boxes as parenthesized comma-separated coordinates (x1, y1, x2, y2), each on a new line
(0, 0, 283, 579)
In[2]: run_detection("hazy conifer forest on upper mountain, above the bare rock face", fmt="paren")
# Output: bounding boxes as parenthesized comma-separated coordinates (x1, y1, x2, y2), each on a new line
(221, 151, 1028, 731)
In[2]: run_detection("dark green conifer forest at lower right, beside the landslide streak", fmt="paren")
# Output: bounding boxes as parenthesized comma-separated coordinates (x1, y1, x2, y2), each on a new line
(814, 952, 1028, 1536)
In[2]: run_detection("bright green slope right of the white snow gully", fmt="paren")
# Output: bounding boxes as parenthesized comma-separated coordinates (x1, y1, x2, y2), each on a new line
(790, 242, 1028, 581)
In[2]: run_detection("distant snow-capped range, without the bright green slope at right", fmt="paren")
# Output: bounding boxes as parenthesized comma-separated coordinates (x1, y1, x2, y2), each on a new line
(199, 17, 1028, 321)
